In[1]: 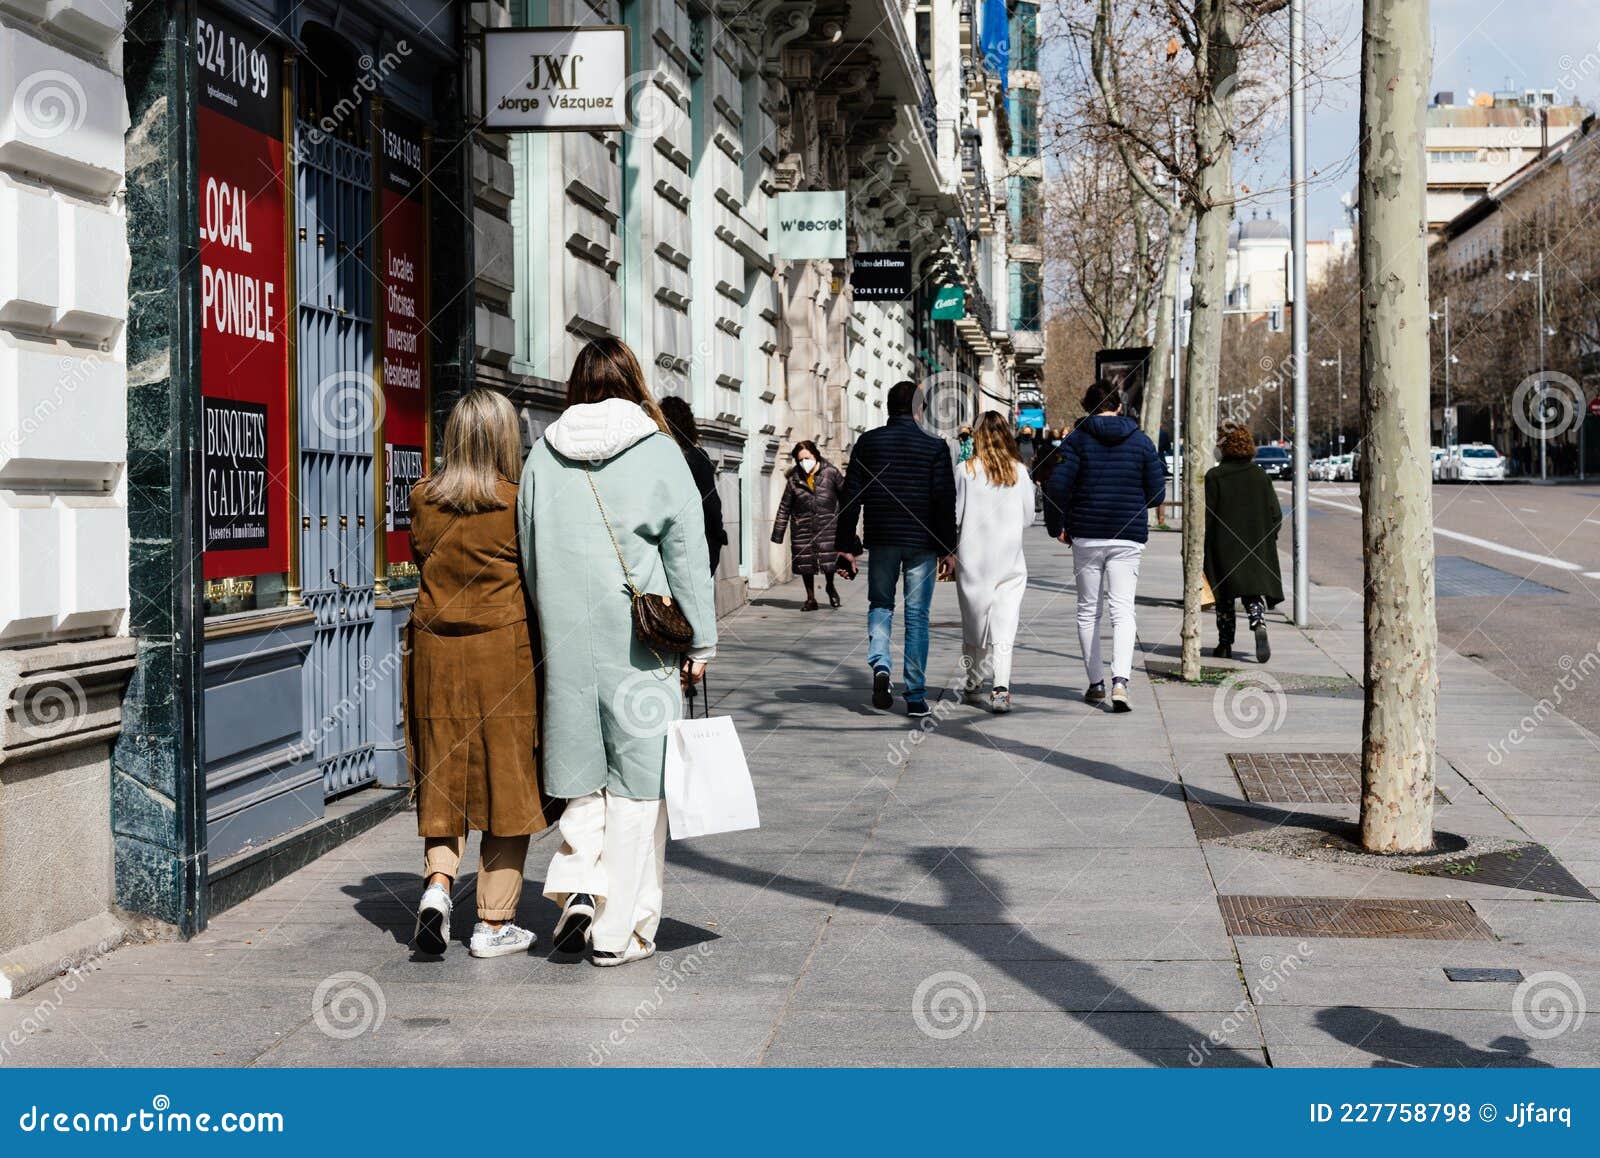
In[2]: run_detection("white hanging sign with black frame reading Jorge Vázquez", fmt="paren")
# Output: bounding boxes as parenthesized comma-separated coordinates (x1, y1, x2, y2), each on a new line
(483, 24, 630, 133)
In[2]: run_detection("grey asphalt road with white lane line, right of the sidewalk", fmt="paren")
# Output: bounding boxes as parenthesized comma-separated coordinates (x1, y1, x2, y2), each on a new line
(1278, 483, 1600, 733)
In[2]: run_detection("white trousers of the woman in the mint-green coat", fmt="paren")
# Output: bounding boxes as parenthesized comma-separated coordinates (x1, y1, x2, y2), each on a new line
(544, 790, 667, 953)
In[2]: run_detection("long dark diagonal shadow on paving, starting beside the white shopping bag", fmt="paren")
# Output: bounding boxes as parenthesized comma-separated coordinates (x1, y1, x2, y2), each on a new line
(675, 846, 1262, 1068)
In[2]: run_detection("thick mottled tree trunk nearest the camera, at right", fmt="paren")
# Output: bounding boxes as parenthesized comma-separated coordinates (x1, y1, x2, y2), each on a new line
(1358, 0, 1438, 853)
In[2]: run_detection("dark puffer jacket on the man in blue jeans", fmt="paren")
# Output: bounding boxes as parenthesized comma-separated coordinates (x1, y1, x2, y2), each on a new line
(838, 414, 955, 555)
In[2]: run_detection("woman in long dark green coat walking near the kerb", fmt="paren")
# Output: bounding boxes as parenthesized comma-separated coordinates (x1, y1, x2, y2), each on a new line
(1205, 424, 1283, 664)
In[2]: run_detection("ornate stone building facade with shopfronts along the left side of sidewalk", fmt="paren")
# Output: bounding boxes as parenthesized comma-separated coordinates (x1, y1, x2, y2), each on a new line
(0, 0, 1037, 993)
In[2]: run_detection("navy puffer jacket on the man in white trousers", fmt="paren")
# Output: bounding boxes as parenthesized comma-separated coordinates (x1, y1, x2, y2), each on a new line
(1045, 414, 1166, 542)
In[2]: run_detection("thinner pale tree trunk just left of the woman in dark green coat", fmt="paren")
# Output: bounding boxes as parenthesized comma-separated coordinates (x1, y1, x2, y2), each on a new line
(1182, 0, 1235, 680)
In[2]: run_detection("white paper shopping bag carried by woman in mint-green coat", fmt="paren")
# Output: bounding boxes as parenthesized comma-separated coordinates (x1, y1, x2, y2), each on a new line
(664, 715, 762, 840)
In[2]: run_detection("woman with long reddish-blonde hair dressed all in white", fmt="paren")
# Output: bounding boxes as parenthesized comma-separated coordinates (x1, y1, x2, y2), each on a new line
(955, 411, 1034, 712)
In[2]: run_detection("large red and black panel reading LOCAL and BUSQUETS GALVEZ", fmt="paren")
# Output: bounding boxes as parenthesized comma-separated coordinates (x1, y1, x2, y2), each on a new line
(195, 10, 290, 579)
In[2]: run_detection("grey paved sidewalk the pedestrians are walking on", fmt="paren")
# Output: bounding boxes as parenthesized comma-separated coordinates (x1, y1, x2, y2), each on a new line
(0, 531, 1600, 1067)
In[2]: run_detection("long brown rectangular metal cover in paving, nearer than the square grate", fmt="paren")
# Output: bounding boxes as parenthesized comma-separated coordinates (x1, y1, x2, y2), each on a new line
(1218, 896, 1494, 940)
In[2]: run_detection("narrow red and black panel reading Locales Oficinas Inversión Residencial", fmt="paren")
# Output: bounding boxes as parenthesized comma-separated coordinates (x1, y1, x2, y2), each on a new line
(382, 107, 429, 569)
